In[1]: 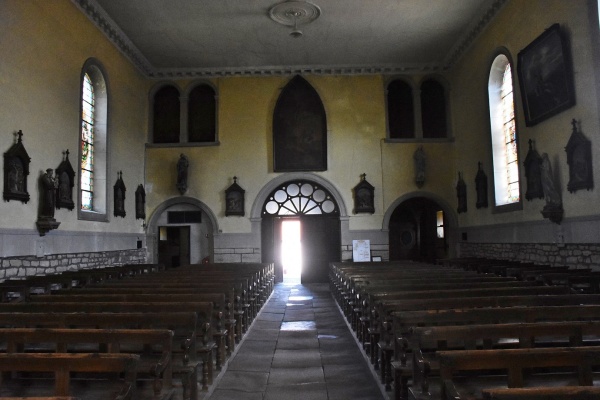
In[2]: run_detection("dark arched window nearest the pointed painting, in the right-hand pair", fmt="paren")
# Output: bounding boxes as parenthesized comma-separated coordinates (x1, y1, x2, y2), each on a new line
(387, 79, 415, 139)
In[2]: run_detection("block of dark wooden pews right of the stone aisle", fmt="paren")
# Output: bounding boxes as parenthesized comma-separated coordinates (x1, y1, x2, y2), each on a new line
(330, 258, 600, 400)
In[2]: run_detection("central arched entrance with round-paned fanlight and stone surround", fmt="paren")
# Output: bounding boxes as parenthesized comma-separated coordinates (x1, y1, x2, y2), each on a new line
(251, 173, 347, 283)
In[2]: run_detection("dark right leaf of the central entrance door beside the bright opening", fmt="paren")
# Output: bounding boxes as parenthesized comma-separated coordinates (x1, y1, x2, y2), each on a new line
(300, 216, 341, 283)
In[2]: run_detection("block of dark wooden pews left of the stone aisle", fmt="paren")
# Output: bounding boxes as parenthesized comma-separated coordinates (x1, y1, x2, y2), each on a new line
(0, 263, 274, 400)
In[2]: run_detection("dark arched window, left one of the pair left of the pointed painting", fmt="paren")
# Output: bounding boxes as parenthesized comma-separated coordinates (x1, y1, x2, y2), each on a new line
(152, 85, 181, 143)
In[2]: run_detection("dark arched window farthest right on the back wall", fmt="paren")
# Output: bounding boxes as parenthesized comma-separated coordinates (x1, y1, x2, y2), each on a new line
(421, 79, 448, 139)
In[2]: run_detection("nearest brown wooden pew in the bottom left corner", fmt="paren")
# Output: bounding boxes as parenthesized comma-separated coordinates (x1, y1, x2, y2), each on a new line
(0, 353, 139, 400)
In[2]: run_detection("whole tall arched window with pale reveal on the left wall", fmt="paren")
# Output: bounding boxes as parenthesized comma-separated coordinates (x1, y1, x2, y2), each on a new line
(78, 59, 108, 221)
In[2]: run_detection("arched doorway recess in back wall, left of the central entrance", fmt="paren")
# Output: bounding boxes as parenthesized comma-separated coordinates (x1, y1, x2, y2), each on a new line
(147, 196, 219, 264)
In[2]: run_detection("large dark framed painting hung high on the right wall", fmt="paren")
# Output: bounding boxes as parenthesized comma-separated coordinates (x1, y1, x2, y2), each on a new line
(518, 24, 575, 126)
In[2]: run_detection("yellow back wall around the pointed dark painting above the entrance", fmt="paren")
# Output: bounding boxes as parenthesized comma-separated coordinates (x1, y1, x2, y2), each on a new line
(146, 76, 454, 233)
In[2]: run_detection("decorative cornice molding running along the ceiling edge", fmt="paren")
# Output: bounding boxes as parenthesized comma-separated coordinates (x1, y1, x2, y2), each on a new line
(71, 0, 508, 79)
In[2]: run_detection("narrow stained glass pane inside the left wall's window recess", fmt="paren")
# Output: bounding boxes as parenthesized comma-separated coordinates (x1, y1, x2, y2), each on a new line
(81, 74, 95, 211)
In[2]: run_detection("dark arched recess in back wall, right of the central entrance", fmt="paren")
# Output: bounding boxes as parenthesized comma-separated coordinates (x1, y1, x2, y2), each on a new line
(383, 191, 458, 261)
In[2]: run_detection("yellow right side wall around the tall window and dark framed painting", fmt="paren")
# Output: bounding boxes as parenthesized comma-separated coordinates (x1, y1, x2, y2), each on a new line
(449, 0, 600, 226)
